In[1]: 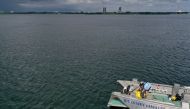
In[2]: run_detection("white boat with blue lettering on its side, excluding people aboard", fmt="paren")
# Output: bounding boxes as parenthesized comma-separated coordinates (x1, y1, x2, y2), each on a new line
(108, 79, 190, 109)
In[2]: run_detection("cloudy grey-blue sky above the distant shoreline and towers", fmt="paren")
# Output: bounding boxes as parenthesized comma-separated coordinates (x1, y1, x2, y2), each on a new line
(0, 0, 190, 12)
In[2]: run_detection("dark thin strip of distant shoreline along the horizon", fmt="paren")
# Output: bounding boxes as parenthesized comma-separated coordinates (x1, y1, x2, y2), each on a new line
(0, 11, 189, 15)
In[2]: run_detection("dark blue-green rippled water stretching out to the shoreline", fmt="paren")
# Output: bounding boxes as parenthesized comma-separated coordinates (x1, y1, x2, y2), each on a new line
(0, 15, 190, 109)
